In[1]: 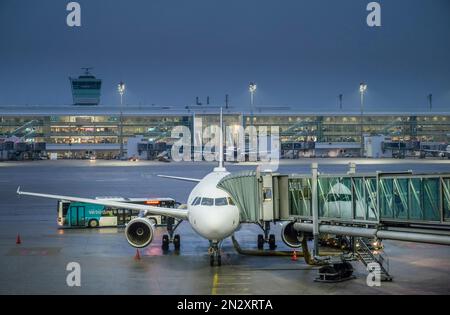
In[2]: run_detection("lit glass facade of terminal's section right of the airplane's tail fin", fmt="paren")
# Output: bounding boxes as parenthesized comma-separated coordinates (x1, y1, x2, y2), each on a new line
(243, 114, 450, 143)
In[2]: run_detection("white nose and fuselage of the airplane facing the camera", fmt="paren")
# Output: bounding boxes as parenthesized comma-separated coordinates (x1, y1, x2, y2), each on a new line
(187, 168, 239, 241)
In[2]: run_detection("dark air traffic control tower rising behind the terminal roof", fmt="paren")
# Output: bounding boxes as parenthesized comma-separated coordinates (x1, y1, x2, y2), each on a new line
(69, 68, 102, 105)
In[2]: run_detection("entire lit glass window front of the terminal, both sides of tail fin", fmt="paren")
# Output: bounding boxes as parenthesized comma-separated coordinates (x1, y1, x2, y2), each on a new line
(0, 113, 450, 149)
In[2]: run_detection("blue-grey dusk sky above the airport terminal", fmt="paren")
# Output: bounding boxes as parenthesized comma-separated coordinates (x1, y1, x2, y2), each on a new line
(0, 0, 450, 112)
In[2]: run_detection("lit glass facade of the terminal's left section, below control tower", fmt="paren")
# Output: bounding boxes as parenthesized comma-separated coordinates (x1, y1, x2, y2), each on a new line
(0, 115, 192, 144)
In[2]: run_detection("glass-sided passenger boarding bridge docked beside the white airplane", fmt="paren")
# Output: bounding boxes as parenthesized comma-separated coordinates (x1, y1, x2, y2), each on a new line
(218, 163, 450, 253)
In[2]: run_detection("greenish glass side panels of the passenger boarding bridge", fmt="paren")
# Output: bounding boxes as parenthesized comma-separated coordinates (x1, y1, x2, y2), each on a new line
(288, 175, 450, 223)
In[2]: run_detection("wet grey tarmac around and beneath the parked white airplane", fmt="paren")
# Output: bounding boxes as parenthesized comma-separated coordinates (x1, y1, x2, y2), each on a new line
(0, 159, 450, 295)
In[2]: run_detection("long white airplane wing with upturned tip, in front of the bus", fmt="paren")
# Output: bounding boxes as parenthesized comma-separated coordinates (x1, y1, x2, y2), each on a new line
(17, 186, 188, 220)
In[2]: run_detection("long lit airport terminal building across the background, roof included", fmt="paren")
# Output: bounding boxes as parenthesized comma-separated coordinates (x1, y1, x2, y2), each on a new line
(0, 105, 450, 158)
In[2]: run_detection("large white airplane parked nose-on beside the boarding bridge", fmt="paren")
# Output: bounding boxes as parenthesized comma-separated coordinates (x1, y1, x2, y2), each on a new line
(17, 110, 268, 266)
